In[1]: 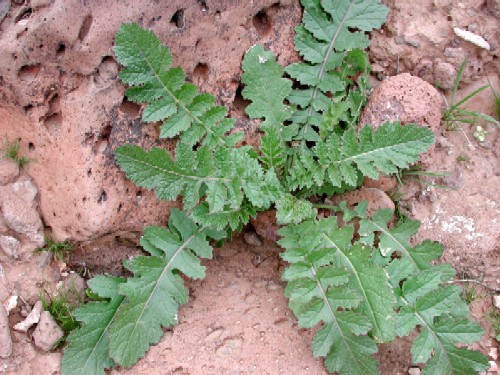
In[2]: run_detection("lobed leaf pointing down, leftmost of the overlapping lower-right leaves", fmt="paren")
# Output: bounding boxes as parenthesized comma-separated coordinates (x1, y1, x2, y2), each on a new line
(279, 218, 380, 375)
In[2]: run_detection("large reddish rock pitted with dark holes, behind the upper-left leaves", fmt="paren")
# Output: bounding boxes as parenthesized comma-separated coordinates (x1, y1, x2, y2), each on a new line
(0, 0, 301, 240)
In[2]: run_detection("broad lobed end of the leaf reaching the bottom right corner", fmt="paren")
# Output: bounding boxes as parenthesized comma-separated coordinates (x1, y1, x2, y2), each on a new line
(398, 274, 489, 375)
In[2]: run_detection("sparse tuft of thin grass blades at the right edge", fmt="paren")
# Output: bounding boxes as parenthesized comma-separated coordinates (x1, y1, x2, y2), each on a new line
(443, 60, 500, 130)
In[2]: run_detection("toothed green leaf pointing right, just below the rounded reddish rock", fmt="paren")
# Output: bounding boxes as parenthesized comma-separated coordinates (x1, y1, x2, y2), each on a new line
(288, 123, 434, 190)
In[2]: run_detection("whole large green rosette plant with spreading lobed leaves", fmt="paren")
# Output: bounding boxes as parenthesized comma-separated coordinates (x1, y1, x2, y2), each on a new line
(62, 0, 488, 374)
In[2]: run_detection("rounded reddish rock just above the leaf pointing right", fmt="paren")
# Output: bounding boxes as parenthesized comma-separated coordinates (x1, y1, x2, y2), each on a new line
(359, 73, 442, 136)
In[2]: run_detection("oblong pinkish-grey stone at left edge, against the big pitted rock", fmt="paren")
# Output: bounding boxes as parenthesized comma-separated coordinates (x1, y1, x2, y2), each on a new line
(0, 185, 45, 247)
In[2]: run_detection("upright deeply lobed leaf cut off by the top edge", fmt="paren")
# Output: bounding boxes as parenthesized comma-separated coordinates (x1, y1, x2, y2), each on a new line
(285, 0, 389, 141)
